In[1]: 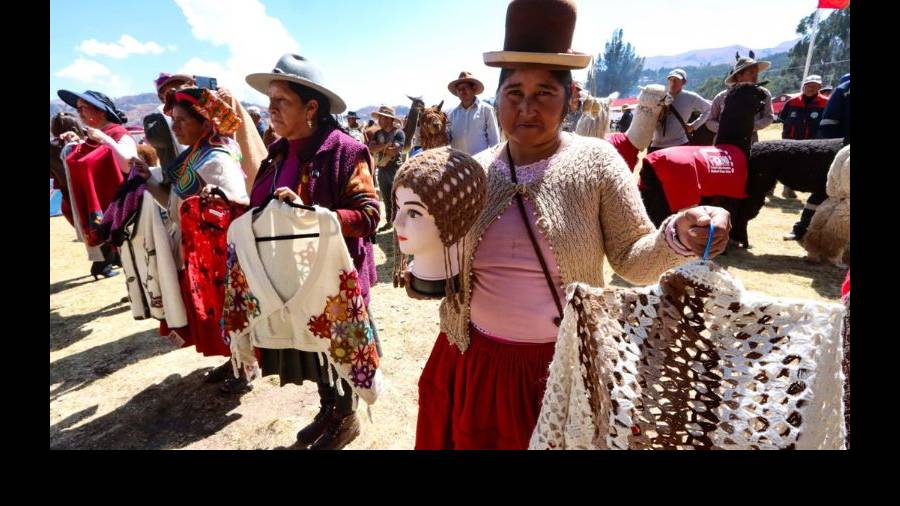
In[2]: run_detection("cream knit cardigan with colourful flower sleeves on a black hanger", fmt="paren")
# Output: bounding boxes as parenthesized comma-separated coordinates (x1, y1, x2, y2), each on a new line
(222, 200, 383, 404)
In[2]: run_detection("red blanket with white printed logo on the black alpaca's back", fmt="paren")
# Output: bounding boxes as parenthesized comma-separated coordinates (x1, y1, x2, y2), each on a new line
(644, 144, 747, 212)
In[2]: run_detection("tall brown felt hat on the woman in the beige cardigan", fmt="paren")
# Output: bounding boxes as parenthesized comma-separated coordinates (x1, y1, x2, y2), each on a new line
(484, 0, 591, 70)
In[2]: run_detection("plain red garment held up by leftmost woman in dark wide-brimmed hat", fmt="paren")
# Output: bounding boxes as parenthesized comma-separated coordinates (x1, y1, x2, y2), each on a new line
(66, 123, 128, 246)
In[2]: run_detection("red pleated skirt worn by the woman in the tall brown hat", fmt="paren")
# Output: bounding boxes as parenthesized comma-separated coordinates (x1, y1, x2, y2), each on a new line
(416, 329, 555, 450)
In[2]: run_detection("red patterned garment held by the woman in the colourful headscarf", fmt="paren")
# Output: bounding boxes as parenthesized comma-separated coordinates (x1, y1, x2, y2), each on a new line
(179, 197, 247, 357)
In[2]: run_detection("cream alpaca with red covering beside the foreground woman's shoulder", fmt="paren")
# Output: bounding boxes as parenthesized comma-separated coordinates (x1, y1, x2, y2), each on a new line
(606, 84, 672, 171)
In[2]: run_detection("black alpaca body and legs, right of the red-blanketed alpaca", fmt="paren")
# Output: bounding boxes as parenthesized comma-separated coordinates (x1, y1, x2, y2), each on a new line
(731, 139, 844, 248)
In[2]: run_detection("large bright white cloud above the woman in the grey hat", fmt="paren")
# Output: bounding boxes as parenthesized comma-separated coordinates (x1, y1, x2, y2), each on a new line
(175, 0, 300, 102)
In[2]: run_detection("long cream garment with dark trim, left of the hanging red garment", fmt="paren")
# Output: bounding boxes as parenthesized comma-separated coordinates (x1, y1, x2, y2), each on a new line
(121, 168, 188, 326)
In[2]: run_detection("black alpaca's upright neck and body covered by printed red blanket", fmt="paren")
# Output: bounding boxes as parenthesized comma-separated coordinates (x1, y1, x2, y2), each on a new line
(639, 83, 766, 226)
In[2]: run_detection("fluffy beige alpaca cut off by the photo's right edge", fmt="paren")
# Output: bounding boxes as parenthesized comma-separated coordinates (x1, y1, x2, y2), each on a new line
(800, 145, 850, 268)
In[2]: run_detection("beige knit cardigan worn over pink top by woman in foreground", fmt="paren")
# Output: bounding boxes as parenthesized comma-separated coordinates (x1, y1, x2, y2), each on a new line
(440, 134, 693, 352)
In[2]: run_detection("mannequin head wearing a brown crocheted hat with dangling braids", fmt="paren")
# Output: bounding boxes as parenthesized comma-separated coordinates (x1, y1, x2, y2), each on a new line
(393, 146, 487, 296)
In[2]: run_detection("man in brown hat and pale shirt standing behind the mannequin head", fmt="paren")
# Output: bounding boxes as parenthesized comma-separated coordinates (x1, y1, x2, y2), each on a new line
(447, 72, 500, 155)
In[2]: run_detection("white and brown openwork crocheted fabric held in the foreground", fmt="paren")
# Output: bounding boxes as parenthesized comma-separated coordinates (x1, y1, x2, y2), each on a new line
(530, 262, 845, 450)
